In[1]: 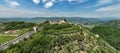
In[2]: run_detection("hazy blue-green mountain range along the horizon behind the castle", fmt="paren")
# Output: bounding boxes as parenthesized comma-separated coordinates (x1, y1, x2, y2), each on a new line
(0, 17, 120, 24)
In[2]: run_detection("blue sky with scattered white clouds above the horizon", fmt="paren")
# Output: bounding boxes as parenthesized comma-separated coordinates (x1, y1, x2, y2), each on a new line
(0, 0, 120, 18)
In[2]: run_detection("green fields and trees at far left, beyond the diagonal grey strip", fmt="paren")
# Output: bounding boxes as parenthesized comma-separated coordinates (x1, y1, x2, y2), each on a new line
(0, 21, 37, 45)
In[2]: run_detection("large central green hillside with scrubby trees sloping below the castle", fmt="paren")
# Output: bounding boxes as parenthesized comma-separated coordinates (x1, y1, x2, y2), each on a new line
(0, 23, 117, 53)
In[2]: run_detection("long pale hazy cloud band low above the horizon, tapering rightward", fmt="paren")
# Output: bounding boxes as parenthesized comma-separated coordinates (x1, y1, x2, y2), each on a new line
(0, 6, 99, 17)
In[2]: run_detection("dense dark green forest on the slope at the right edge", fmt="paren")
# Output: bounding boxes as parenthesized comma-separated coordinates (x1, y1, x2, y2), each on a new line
(91, 26, 120, 50)
